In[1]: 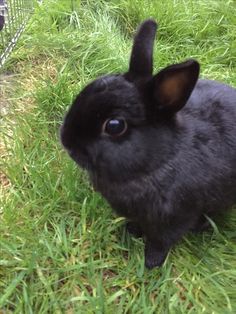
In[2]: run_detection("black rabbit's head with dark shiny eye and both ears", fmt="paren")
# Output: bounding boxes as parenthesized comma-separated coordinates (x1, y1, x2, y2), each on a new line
(61, 19, 199, 180)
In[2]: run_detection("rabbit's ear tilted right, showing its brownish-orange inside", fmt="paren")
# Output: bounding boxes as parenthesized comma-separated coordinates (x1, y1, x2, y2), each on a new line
(151, 60, 200, 113)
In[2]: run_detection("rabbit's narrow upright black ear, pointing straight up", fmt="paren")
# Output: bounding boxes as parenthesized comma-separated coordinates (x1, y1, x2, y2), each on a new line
(126, 19, 157, 80)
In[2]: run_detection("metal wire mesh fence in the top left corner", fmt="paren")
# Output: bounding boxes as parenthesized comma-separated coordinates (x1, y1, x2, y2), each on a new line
(0, 0, 35, 68)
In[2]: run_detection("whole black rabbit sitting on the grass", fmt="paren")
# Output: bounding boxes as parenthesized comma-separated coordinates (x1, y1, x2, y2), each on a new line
(61, 19, 236, 268)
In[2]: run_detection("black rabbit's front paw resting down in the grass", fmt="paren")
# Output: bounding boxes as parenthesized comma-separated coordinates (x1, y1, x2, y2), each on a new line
(145, 242, 168, 269)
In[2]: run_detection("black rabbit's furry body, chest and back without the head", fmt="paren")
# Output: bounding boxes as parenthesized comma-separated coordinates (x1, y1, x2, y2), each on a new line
(88, 80, 236, 266)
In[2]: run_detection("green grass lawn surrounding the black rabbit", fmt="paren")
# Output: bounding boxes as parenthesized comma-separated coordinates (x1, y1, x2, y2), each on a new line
(0, 0, 236, 314)
